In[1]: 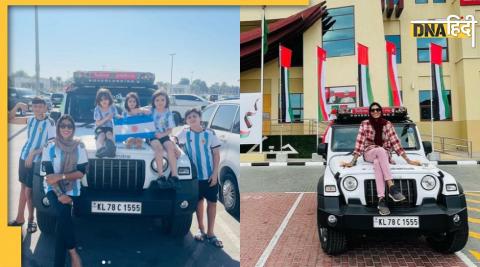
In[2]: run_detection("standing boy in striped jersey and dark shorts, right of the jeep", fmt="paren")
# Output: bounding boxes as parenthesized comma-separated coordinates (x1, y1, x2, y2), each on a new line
(176, 109, 223, 248)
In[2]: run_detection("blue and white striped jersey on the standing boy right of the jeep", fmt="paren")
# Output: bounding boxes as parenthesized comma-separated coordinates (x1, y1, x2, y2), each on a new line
(177, 127, 220, 180)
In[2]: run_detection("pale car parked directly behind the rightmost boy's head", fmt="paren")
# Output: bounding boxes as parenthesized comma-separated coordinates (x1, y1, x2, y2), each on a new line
(170, 94, 211, 125)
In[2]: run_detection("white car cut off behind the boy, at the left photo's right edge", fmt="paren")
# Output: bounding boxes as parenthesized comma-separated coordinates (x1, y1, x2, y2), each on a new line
(202, 101, 240, 216)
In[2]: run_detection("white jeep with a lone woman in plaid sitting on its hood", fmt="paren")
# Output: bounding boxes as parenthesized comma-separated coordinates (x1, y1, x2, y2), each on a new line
(317, 107, 468, 254)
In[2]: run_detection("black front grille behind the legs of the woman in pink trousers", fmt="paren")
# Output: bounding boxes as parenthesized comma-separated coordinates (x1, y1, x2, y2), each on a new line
(365, 179, 417, 208)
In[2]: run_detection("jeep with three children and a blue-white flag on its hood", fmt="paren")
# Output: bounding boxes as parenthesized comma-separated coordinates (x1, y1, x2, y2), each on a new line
(33, 71, 198, 236)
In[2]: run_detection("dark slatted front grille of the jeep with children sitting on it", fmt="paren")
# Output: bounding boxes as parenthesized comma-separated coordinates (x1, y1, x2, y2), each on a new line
(87, 159, 145, 191)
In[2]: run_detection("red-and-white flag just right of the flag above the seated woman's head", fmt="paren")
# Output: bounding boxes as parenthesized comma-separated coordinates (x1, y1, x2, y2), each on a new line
(387, 41, 402, 106)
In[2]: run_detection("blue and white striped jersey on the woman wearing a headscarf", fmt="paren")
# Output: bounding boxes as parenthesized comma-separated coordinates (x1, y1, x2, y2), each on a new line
(40, 142, 88, 197)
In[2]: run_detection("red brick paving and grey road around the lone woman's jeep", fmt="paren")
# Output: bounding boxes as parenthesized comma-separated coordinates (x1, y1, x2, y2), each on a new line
(240, 165, 480, 266)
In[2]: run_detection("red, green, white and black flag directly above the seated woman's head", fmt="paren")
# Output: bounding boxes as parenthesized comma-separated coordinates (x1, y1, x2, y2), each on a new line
(357, 43, 373, 107)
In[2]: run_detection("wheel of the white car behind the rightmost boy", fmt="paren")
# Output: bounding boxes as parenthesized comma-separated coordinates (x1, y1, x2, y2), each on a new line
(220, 173, 240, 216)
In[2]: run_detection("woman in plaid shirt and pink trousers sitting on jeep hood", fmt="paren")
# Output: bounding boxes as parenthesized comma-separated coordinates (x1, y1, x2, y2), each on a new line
(342, 102, 421, 215)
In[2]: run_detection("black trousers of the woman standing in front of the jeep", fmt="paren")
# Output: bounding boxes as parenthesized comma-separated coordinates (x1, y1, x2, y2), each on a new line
(47, 191, 76, 267)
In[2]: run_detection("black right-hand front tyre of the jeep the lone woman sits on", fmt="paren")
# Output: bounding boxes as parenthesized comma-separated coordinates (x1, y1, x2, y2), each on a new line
(427, 223, 468, 254)
